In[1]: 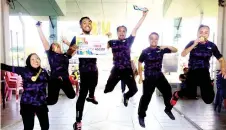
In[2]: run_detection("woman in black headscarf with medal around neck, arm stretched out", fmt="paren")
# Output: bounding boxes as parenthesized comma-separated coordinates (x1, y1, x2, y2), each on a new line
(1, 53, 49, 130)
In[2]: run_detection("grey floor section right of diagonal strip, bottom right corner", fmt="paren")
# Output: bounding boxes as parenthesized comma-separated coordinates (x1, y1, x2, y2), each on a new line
(175, 99, 226, 130)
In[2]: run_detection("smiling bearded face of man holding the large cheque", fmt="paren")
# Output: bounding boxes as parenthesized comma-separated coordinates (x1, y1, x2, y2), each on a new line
(80, 18, 92, 34)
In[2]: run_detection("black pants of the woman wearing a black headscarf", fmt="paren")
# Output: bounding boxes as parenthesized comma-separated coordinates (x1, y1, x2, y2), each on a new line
(20, 104, 49, 130)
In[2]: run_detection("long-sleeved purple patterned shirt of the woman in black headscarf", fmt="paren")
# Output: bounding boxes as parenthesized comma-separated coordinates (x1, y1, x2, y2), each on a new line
(1, 64, 49, 106)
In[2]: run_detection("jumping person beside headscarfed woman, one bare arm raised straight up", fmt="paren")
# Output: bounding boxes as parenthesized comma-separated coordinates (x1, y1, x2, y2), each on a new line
(36, 22, 76, 105)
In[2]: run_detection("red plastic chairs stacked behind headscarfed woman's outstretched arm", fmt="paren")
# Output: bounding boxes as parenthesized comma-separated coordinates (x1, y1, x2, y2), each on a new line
(5, 72, 23, 102)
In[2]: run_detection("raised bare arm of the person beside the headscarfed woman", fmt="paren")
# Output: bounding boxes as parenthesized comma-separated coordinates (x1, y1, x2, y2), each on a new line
(36, 22, 50, 50)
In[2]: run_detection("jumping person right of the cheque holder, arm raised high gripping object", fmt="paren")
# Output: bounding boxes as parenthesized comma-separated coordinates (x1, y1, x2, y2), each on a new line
(104, 11, 148, 107)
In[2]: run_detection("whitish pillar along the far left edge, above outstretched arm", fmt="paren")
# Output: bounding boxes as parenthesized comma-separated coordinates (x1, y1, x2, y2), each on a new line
(0, 0, 11, 65)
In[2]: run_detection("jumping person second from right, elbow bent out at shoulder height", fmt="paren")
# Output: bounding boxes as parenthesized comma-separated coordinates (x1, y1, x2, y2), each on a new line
(138, 32, 177, 127)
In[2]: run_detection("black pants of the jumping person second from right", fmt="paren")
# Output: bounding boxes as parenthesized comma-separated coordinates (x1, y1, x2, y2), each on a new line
(138, 73, 173, 117)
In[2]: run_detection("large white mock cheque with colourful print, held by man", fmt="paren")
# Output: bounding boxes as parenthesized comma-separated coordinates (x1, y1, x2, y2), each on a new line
(76, 35, 108, 58)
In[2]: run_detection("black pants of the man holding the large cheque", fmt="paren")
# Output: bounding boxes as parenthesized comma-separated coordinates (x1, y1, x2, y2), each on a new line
(76, 71, 98, 122)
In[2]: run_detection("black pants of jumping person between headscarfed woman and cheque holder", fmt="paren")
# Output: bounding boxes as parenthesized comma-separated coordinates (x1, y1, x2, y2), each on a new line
(47, 77, 75, 105)
